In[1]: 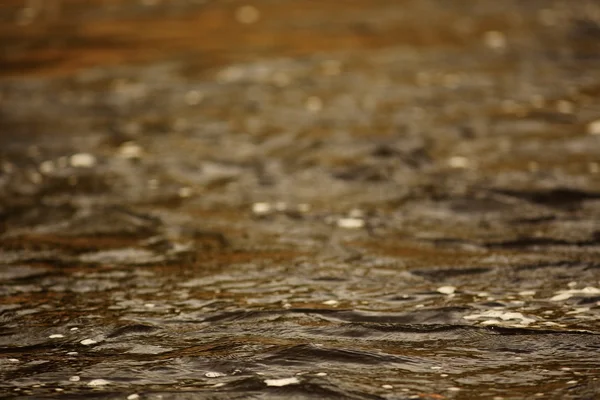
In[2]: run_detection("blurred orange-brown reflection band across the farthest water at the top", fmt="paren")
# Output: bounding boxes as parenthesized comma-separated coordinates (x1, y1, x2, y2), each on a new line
(0, 0, 514, 76)
